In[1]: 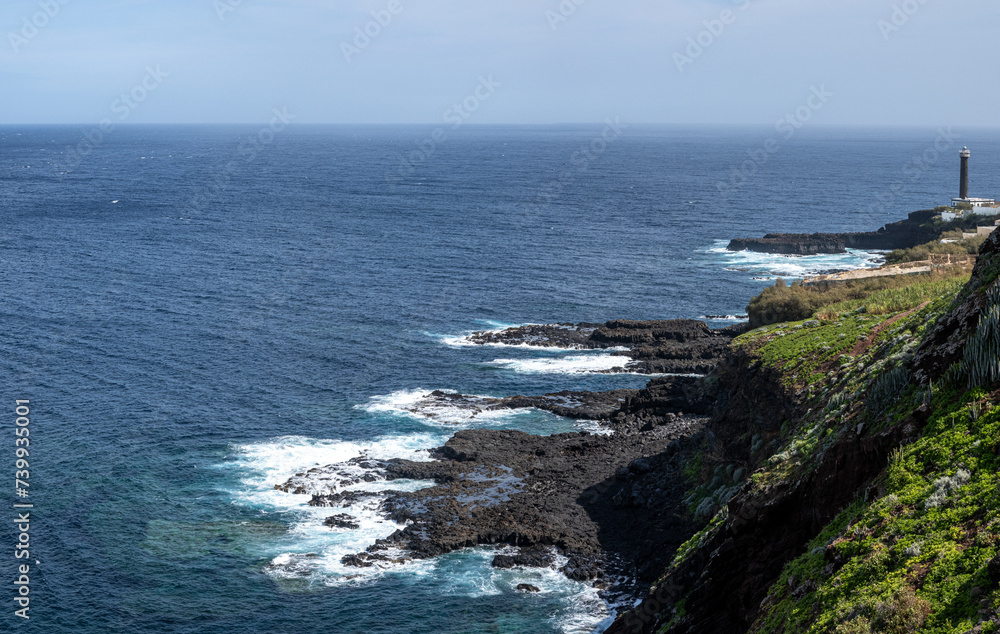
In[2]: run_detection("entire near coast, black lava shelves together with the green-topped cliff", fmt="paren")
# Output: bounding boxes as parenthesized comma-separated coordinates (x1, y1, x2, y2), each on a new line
(276, 220, 1000, 634)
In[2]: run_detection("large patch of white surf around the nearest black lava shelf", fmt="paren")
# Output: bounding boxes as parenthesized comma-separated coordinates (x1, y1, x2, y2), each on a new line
(222, 428, 614, 634)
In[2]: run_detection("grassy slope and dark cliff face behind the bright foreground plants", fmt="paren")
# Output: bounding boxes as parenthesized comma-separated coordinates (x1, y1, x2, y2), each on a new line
(612, 278, 966, 632)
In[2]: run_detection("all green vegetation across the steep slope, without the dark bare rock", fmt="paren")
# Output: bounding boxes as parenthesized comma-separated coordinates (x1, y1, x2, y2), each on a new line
(648, 238, 1000, 634)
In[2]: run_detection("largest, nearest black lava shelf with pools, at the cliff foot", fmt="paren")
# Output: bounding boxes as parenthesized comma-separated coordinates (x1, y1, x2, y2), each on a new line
(293, 417, 702, 582)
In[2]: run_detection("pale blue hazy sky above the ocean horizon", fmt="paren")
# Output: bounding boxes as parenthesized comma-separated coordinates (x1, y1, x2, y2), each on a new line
(0, 0, 1000, 127)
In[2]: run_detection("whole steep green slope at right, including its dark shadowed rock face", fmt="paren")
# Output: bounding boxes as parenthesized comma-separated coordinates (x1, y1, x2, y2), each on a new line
(610, 235, 1000, 634)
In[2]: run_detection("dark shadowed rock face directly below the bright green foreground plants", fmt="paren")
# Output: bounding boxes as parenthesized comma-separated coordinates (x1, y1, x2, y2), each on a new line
(608, 408, 921, 634)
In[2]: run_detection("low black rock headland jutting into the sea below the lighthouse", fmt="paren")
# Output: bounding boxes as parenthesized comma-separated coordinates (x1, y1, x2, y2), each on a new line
(727, 210, 939, 255)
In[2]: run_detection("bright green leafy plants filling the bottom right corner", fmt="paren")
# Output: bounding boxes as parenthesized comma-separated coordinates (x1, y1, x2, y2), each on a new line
(755, 390, 1000, 634)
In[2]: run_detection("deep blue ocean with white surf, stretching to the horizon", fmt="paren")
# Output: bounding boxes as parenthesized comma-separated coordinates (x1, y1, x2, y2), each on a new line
(0, 125, 1000, 634)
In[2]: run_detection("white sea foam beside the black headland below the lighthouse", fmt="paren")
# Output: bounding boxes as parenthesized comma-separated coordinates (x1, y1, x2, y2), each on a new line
(704, 240, 884, 279)
